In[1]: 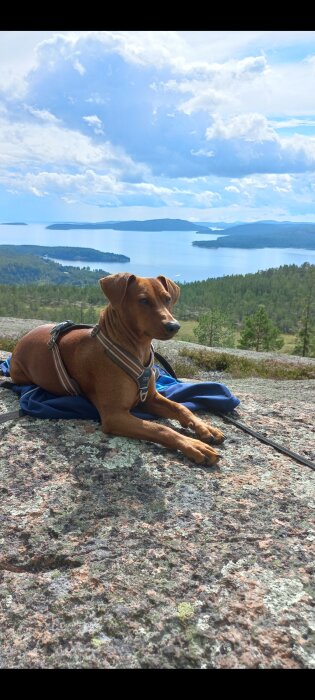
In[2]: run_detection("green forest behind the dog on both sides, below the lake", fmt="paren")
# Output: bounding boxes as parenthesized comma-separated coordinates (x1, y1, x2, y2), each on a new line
(0, 257, 315, 342)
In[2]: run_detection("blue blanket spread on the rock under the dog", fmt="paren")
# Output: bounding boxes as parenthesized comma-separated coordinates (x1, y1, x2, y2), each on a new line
(0, 358, 240, 421)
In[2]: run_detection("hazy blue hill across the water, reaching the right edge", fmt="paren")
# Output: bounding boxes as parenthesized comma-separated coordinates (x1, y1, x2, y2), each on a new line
(193, 221, 315, 250)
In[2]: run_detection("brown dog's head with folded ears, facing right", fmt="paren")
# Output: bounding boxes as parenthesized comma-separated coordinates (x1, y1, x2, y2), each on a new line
(100, 272, 180, 340)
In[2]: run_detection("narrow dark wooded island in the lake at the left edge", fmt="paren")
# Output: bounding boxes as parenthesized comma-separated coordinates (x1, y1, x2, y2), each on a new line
(0, 245, 130, 263)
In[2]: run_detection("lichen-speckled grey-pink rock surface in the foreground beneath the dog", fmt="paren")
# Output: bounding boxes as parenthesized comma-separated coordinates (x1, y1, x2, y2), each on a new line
(0, 321, 315, 669)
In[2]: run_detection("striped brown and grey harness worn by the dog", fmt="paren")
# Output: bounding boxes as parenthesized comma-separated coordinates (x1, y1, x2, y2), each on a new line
(48, 321, 159, 402)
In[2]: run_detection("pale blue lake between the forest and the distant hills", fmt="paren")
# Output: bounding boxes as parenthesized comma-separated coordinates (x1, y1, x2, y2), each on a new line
(0, 224, 315, 282)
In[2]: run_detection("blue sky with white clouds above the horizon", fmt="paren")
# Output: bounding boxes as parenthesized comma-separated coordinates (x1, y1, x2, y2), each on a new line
(0, 30, 315, 223)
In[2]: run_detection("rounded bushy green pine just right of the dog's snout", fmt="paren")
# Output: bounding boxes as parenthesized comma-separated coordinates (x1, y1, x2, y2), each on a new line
(194, 309, 235, 348)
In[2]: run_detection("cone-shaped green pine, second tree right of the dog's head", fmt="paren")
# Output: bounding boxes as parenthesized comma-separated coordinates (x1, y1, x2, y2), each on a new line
(239, 304, 283, 352)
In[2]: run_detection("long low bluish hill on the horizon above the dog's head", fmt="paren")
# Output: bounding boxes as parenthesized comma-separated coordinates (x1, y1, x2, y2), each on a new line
(46, 219, 211, 233)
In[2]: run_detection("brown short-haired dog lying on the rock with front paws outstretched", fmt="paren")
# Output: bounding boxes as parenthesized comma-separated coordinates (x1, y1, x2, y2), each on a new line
(10, 273, 223, 464)
